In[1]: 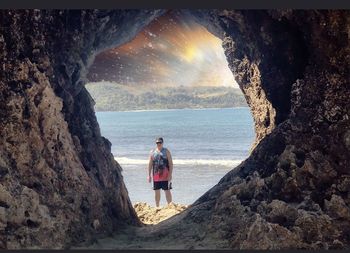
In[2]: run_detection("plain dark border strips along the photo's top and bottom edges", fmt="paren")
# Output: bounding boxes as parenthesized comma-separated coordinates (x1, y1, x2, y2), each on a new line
(0, 0, 350, 253)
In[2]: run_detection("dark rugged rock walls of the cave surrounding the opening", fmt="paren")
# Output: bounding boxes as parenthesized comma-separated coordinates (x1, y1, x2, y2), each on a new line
(0, 10, 350, 249)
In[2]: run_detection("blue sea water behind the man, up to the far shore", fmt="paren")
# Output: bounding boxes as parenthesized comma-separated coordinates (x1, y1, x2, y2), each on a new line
(96, 107, 255, 206)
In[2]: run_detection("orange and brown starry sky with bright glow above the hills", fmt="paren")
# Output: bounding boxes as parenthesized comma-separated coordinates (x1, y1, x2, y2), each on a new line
(88, 12, 238, 88)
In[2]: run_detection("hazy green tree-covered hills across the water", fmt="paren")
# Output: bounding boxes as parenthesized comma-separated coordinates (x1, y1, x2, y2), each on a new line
(86, 82, 247, 111)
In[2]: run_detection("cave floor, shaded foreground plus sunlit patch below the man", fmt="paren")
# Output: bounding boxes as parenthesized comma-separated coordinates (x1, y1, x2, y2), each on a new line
(70, 202, 227, 250)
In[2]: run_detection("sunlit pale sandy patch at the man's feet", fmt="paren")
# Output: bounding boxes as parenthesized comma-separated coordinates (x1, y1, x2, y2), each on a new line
(134, 202, 188, 225)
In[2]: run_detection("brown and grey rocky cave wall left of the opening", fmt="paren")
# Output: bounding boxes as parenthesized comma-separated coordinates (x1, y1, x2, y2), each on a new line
(0, 10, 161, 249)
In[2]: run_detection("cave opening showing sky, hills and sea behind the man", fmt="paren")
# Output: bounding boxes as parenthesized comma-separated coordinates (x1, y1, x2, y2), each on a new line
(85, 11, 255, 219)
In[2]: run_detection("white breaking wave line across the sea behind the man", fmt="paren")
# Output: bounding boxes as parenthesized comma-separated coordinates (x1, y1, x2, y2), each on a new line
(114, 157, 243, 167)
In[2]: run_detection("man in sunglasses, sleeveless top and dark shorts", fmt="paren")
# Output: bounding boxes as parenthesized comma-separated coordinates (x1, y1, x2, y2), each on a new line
(147, 137, 173, 207)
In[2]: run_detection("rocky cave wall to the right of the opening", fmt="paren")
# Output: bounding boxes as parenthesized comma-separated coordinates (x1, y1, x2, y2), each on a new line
(171, 10, 350, 249)
